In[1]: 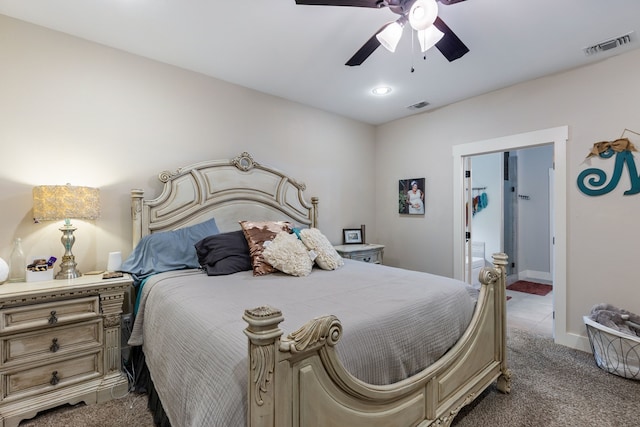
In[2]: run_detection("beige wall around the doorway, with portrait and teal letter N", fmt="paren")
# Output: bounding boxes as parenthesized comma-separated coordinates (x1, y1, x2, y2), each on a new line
(376, 46, 640, 348)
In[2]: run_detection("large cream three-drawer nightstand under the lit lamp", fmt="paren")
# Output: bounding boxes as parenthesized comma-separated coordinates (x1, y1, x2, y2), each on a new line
(0, 275, 132, 427)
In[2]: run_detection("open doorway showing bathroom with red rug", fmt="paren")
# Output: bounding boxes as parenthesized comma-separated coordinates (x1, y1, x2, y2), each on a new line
(467, 144, 553, 336)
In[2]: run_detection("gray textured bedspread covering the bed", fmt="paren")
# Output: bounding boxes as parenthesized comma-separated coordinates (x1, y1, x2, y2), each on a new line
(129, 260, 477, 427)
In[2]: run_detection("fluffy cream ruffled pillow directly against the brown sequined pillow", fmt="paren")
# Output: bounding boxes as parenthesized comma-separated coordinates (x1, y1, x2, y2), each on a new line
(262, 231, 313, 276)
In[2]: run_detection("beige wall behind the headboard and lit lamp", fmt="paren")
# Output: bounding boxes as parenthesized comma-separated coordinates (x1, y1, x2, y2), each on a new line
(0, 15, 375, 272)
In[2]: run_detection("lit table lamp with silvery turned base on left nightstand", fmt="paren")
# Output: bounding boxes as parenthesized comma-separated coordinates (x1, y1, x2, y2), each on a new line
(33, 184, 100, 279)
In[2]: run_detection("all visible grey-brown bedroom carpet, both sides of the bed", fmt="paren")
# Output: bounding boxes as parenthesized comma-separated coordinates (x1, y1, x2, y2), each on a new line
(15, 329, 640, 427)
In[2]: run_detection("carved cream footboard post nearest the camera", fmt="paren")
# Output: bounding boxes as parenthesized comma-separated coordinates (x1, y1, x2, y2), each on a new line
(242, 306, 284, 427)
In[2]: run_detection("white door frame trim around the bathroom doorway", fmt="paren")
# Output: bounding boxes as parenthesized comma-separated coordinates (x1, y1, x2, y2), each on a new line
(452, 126, 568, 348)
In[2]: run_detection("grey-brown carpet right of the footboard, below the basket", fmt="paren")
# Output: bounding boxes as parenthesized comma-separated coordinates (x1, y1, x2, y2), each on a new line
(452, 329, 640, 427)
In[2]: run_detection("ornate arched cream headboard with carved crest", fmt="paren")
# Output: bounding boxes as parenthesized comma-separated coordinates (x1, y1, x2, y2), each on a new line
(131, 152, 318, 247)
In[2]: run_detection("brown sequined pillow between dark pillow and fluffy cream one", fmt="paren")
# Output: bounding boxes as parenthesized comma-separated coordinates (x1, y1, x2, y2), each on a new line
(240, 221, 293, 276)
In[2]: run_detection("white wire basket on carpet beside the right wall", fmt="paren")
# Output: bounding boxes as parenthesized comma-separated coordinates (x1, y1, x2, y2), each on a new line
(583, 316, 640, 380)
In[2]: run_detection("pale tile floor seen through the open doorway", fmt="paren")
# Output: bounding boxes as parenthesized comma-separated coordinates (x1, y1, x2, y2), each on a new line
(507, 279, 553, 337)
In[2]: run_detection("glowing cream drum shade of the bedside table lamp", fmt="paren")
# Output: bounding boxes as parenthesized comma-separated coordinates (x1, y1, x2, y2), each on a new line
(33, 184, 100, 221)
